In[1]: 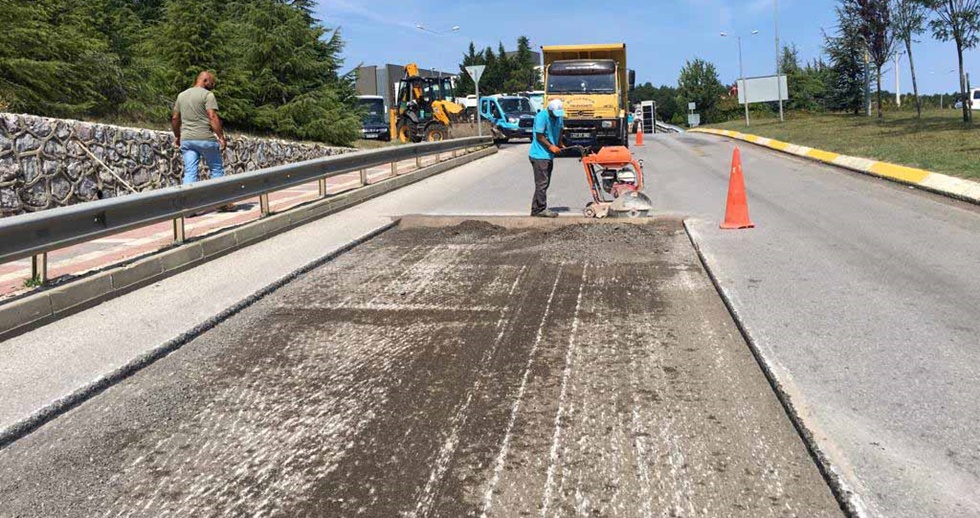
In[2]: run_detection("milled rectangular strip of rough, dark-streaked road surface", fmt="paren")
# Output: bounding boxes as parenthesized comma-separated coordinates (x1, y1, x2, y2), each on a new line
(0, 218, 840, 517)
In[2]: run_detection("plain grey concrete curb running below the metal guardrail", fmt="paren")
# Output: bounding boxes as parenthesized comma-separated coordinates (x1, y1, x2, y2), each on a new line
(0, 146, 497, 341)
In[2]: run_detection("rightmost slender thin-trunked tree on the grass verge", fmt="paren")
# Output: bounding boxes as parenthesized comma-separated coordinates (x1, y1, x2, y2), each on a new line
(923, 0, 980, 122)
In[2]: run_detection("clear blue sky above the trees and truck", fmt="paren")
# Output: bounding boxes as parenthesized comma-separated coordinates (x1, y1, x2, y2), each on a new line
(317, 0, 980, 93)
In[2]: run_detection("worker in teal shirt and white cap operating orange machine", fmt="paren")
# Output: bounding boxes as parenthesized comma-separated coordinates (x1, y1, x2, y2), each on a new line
(529, 99, 565, 218)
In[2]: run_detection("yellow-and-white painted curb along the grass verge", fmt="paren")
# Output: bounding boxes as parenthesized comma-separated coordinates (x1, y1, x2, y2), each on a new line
(688, 128, 980, 204)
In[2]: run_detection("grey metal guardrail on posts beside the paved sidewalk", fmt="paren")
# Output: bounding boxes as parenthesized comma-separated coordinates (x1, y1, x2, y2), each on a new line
(0, 137, 492, 282)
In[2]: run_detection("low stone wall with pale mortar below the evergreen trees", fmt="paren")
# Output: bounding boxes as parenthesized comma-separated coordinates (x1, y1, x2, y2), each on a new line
(0, 113, 354, 216)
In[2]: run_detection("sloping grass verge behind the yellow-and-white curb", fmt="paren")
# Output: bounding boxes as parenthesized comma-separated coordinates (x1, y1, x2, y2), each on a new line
(708, 110, 980, 180)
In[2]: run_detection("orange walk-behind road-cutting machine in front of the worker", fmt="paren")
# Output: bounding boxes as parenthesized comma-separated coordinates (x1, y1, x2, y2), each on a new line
(569, 146, 653, 218)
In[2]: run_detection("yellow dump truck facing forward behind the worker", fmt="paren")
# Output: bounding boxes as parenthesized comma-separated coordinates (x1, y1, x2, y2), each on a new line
(541, 43, 635, 149)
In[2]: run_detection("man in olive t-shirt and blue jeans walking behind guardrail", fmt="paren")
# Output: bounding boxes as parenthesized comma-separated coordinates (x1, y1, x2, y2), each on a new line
(170, 71, 225, 185)
